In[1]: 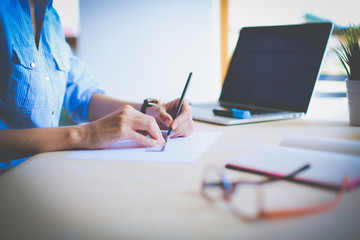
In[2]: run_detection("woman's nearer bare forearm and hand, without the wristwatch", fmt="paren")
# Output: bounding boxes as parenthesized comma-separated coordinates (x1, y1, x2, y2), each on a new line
(0, 95, 164, 161)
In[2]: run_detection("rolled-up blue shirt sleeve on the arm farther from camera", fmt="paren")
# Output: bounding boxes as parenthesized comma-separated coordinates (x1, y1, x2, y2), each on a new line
(64, 54, 105, 122)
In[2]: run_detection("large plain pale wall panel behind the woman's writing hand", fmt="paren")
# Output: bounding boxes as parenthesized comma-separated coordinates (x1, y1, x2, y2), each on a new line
(78, 0, 220, 102)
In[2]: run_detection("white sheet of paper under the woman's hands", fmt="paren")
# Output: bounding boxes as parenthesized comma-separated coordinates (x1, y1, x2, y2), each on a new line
(66, 132, 221, 163)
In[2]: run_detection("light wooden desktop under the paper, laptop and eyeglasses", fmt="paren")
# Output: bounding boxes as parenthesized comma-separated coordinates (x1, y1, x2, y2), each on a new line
(0, 98, 360, 239)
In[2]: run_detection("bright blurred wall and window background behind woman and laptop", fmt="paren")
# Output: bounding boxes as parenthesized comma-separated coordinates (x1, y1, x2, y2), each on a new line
(54, 0, 360, 106)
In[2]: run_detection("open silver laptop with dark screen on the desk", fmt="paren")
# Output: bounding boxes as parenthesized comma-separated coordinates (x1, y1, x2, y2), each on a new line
(192, 23, 333, 125)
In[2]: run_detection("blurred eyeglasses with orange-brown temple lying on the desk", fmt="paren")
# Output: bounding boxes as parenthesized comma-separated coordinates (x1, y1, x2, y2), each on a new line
(201, 165, 349, 221)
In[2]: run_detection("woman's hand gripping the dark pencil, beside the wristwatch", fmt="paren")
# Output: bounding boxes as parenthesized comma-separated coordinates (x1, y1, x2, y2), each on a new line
(147, 99, 194, 137)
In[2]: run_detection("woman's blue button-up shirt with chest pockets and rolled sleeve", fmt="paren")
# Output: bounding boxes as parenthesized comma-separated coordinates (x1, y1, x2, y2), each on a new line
(0, 0, 103, 168)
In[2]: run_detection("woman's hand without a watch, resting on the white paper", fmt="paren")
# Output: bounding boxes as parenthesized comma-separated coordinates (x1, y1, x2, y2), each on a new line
(83, 105, 165, 149)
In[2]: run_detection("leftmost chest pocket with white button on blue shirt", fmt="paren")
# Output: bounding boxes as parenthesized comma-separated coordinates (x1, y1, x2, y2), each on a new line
(5, 48, 46, 108)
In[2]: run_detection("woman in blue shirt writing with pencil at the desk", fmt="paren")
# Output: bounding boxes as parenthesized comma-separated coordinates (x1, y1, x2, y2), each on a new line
(0, 0, 193, 168)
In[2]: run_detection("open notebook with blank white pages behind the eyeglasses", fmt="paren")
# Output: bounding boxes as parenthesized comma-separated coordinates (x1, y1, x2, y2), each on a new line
(226, 135, 360, 189)
